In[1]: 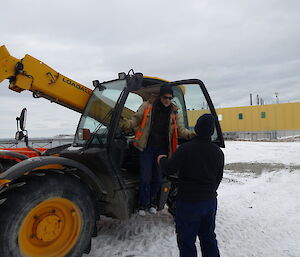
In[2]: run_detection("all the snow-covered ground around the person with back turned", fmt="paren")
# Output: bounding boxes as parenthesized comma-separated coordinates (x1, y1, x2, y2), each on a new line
(85, 141, 300, 257)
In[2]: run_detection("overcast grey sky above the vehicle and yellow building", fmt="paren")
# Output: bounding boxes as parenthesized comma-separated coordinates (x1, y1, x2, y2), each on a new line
(0, 0, 300, 138)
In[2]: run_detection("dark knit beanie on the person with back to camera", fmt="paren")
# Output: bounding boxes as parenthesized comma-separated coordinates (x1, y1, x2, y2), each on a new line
(194, 113, 215, 138)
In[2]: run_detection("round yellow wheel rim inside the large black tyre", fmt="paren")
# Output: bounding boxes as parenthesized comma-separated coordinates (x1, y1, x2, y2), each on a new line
(18, 198, 82, 257)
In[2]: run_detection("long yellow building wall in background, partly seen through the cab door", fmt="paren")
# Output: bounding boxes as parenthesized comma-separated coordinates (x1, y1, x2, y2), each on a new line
(188, 102, 300, 132)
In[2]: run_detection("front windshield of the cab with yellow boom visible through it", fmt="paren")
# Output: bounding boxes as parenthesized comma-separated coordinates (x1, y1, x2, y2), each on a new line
(74, 80, 126, 145)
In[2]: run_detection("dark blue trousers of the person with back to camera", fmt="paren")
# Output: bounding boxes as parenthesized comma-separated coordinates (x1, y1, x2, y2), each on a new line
(175, 199, 220, 257)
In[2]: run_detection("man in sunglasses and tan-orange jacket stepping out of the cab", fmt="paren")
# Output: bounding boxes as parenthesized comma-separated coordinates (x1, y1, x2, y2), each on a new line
(122, 86, 195, 216)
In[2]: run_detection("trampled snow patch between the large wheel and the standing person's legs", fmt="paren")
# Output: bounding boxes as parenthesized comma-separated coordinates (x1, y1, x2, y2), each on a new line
(85, 209, 178, 257)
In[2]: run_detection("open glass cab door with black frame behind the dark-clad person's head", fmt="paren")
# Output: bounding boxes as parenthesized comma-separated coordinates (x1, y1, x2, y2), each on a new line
(171, 79, 225, 148)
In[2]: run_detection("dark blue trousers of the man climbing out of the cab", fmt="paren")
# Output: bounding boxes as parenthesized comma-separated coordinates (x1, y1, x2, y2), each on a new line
(139, 147, 166, 207)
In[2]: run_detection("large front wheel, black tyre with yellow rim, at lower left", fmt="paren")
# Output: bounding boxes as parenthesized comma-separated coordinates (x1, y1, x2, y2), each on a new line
(0, 174, 95, 257)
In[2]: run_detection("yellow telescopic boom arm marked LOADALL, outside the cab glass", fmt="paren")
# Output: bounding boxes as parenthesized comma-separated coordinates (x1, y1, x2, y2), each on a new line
(0, 45, 92, 113)
